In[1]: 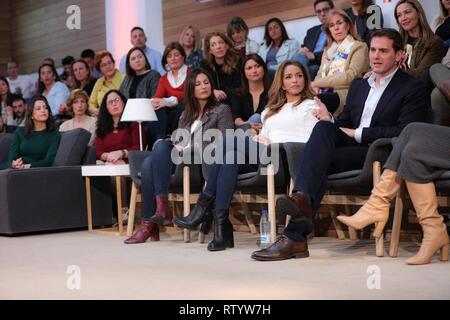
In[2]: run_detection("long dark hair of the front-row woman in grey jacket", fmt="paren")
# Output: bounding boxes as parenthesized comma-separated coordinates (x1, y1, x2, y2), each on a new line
(182, 68, 218, 126)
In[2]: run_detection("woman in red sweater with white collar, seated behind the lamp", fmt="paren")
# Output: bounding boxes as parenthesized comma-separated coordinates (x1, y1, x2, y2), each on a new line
(146, 42, 190, 146)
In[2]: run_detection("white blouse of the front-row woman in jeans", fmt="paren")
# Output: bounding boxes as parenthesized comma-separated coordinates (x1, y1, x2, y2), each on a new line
(260, 99, 319, 143)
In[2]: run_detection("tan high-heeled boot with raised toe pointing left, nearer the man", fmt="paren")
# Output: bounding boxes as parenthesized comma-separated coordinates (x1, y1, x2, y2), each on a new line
(337, 169, 402, 238)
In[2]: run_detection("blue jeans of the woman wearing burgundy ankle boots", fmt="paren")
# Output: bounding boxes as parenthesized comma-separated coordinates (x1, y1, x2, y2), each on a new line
(141, 140, 175, 220)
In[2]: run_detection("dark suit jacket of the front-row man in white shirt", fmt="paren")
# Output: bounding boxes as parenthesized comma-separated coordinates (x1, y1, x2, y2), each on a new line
(335, 69, 430, 144)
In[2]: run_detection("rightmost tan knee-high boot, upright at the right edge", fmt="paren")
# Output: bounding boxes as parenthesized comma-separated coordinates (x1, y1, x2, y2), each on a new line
(406, 181, 448, 264)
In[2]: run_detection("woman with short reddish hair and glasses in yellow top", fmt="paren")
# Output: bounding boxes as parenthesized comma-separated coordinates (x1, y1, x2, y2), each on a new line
(89, 51, 125, 117)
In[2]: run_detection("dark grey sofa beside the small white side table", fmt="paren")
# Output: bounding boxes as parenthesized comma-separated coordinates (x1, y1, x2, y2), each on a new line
(0, 129, 113, 235)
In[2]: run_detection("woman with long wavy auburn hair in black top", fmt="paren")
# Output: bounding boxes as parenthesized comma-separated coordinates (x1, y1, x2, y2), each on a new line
(202, 32, 241, 104)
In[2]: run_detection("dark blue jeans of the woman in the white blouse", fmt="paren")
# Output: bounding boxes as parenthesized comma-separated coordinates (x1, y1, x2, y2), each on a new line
(203, 136, 265, 209)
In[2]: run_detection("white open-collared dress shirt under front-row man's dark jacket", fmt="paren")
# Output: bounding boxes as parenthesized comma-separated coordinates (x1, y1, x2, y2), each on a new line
(355, 68, 398, 143)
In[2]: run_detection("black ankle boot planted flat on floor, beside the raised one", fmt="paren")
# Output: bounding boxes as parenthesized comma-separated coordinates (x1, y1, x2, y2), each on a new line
(208, 209, 234, 251)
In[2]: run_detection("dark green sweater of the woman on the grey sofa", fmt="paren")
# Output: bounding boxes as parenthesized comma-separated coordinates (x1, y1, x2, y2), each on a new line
(0, 127, 61, 169)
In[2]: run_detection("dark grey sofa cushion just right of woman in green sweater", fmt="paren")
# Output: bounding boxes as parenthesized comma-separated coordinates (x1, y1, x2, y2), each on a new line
(53, 128, 91, 167)
